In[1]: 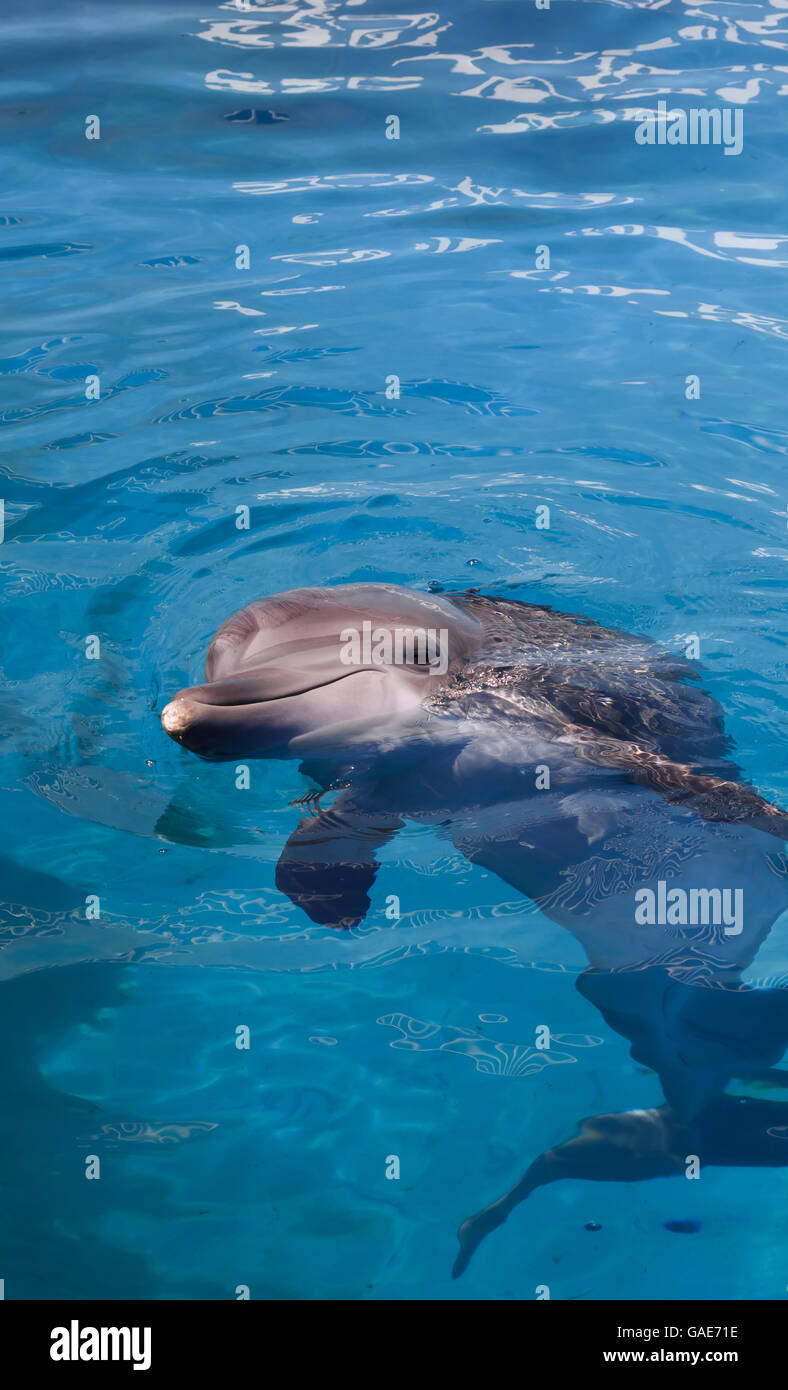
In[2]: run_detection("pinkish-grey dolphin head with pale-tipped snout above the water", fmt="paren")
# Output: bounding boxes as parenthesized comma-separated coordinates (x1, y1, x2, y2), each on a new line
(161, 584, 482, 760)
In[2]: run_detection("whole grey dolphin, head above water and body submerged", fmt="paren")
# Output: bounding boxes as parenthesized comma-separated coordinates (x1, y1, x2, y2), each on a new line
(161, 584, 788, 1276)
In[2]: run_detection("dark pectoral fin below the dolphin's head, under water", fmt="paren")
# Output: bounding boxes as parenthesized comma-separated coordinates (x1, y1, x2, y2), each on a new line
(277, 798, 402, 927)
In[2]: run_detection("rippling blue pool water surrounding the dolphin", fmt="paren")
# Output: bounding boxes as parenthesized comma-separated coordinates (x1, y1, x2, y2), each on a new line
(0, 0, 788, 1300)
